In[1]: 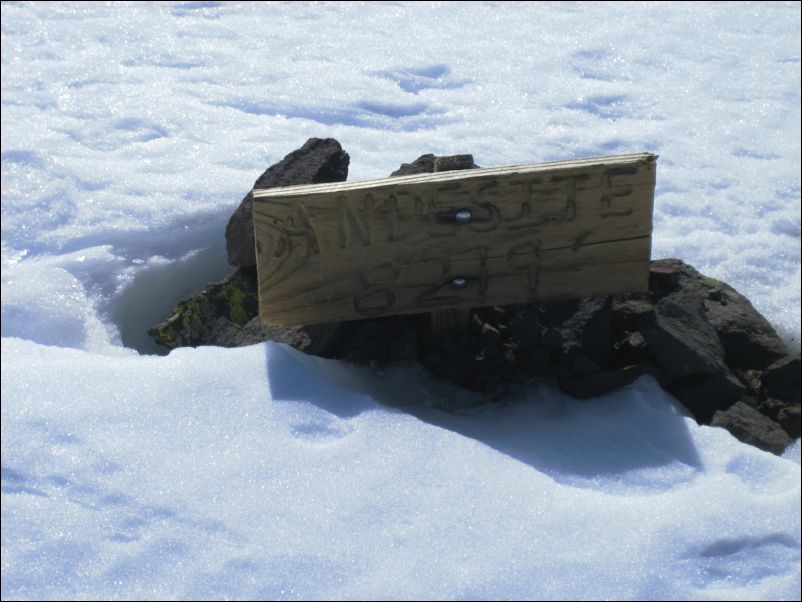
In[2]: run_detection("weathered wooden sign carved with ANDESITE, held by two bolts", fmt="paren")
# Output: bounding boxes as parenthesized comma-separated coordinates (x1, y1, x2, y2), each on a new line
(253, 153, 656, 324)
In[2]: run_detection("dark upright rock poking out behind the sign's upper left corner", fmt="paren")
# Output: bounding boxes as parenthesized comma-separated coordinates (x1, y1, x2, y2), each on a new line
(226, 138, 349, 267)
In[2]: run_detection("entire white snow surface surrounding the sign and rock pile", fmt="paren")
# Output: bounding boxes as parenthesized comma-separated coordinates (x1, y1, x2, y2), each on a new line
(1, 2, 802, 600)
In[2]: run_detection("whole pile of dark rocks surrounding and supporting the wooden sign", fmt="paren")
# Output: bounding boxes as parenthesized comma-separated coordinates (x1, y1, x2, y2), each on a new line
(150, 138, 800, 453)
